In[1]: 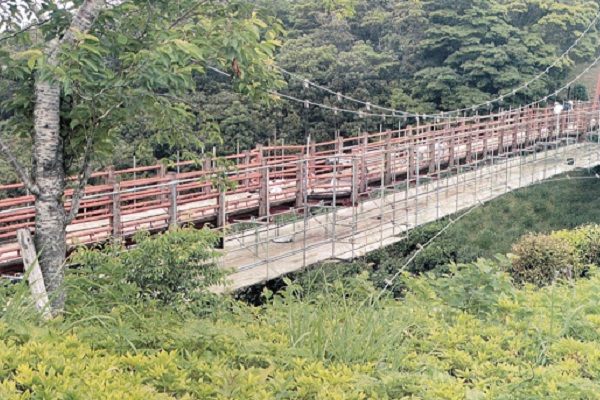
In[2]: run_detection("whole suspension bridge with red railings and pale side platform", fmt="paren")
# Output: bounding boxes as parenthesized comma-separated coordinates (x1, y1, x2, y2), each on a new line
(0, 102, 600, 290)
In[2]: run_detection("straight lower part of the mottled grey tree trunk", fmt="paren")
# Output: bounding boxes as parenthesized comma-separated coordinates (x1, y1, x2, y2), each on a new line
(34, 82, 66, 313)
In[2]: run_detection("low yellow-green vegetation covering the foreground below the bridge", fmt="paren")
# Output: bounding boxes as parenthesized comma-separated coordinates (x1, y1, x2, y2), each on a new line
(5, 223, 600, 400)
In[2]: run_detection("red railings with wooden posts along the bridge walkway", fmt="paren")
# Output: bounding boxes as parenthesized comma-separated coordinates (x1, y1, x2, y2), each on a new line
(0, 103, 599, 265)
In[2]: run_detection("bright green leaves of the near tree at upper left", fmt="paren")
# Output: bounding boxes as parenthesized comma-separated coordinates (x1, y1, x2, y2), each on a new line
(0, 0, 282, 183)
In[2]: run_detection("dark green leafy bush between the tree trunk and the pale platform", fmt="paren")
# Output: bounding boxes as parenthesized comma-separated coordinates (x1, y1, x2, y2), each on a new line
(73, 228, 229, 306)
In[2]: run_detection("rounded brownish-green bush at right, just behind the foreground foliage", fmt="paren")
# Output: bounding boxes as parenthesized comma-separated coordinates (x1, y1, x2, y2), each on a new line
(508, 233, 583, 286)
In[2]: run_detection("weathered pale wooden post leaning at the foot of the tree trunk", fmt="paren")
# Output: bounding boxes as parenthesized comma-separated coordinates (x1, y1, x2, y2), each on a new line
(17, 229, 52, 319)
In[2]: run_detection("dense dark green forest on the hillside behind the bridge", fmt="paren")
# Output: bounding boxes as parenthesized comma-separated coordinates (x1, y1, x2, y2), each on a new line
(0, 0, 599, 180)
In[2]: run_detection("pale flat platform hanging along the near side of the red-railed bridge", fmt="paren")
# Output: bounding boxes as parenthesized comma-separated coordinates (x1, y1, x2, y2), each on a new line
(216, 143, 600, 291)
